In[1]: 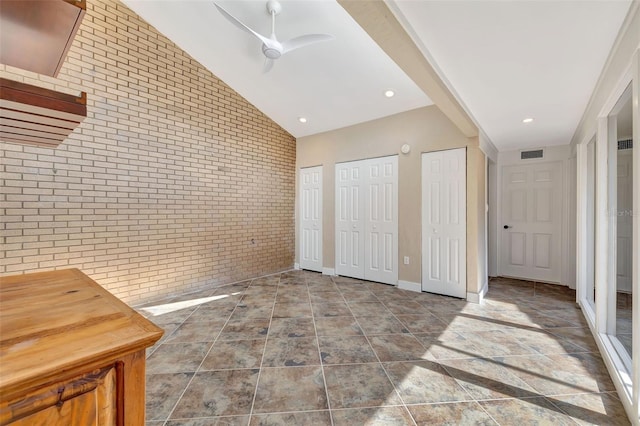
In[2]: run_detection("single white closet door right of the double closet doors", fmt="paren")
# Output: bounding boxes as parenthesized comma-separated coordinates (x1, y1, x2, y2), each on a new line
(422, 148, 467, 298)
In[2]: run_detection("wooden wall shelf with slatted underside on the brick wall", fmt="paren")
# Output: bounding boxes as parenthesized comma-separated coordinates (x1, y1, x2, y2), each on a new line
(0, 78, 87, 148)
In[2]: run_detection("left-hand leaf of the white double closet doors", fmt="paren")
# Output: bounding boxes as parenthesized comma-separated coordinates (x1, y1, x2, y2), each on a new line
(336, 161, 364, 278)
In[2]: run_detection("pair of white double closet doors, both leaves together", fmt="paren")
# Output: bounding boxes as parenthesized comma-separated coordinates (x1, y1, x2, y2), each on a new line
(336, 156, 398, 284)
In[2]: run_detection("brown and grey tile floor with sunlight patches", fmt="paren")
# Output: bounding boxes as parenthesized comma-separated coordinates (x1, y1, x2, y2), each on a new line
(139, 271, 629, 426)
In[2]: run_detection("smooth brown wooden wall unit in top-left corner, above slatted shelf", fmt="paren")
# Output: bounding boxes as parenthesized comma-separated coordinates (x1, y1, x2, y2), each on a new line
(0, 0, 87, 77)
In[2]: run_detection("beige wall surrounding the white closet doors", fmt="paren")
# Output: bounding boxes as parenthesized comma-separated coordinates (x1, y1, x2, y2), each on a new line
(296, 106, 486, 301)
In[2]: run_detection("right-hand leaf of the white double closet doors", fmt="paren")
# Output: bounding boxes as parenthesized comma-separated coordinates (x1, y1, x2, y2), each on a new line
(364, 156, 398, 285)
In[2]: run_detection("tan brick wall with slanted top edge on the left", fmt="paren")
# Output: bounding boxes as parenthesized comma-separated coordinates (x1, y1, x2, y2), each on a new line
(0, 0, 295, 304)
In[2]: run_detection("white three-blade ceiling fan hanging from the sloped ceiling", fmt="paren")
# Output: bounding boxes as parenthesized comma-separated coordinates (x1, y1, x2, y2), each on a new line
(213, 0, 334, 73)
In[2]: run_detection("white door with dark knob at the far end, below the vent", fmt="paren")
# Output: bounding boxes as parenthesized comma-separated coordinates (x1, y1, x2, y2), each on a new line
(499, 161, 562, 283)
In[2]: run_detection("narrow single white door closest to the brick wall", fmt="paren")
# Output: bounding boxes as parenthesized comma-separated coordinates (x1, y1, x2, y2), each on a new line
(300, 166, 322, 272)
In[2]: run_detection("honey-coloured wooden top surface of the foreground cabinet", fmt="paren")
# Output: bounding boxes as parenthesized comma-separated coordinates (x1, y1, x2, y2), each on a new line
(0, 269, 163, 398)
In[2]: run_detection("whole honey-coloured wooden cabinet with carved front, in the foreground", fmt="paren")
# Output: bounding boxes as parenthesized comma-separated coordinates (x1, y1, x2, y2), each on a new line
(0, 269, 163, 426)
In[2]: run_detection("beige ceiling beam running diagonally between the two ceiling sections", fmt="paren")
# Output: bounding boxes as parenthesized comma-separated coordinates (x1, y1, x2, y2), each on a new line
(338, 0, 478, 137)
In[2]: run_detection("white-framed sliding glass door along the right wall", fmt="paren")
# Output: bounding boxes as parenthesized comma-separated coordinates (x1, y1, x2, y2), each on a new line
(576, 50, 640, 423)
